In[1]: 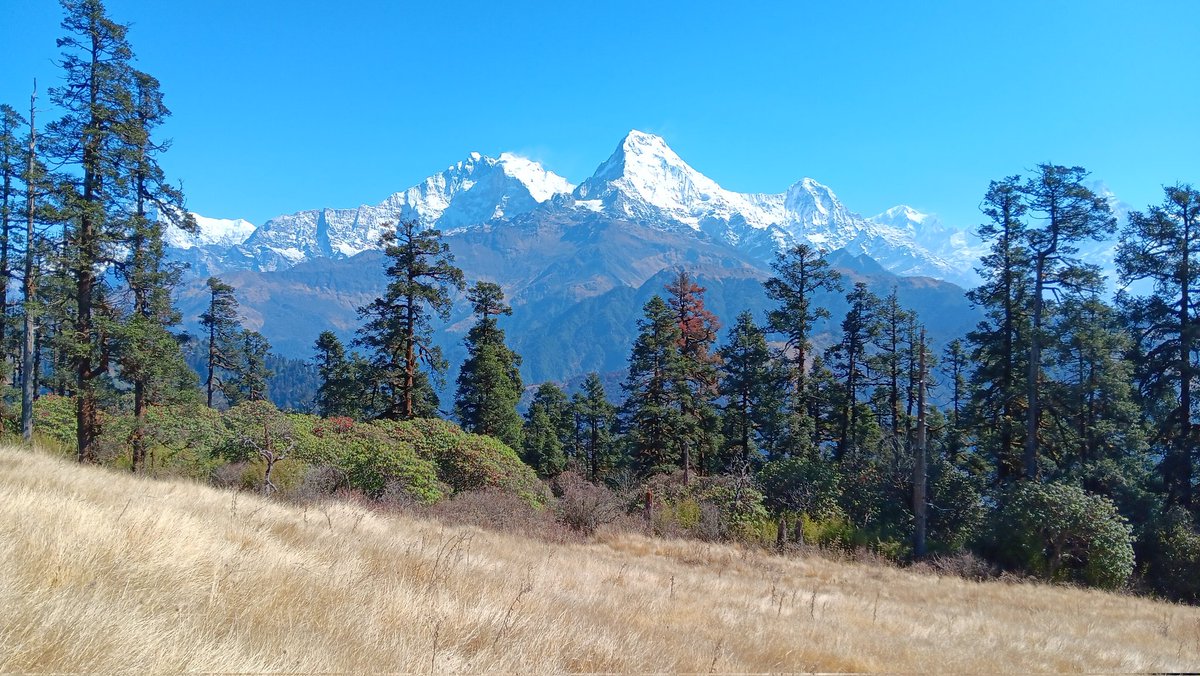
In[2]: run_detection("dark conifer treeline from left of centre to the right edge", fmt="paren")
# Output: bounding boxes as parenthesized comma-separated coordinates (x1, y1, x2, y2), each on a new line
(316, 164, 1200, 600)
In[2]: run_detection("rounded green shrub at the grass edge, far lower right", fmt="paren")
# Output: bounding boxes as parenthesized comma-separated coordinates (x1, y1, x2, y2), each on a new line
(995, 481, 1134, 588)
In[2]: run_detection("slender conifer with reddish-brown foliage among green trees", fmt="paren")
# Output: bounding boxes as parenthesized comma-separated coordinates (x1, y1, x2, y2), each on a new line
(666, 269, 720, 483)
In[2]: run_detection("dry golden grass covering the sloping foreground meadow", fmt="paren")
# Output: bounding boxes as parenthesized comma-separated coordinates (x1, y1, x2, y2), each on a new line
(0, 450, 1200, 672)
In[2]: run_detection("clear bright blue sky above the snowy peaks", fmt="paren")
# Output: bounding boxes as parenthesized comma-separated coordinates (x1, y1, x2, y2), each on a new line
(0, 0, 1200, 226)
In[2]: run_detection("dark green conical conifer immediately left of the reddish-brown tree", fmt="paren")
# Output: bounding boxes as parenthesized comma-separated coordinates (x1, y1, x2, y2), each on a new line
(623, 295, 685, 474)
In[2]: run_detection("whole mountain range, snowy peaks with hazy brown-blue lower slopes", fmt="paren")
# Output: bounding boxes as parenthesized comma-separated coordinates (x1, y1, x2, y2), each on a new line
(167, 131, 982, 391)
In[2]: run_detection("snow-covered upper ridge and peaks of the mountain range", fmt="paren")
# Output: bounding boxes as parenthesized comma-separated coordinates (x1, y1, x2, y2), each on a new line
(170, 131, 974, 283)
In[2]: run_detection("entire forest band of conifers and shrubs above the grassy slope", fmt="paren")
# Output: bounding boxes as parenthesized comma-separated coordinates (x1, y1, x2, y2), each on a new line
(0, 0, 1200, 603)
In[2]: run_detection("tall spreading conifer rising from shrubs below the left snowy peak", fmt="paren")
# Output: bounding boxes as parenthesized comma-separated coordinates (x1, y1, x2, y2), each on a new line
(355, 221, 464, 420)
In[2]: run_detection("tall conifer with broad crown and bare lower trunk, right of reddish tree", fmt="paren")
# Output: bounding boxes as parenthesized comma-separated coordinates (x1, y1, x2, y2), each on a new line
(763, 244, 841, 453)
